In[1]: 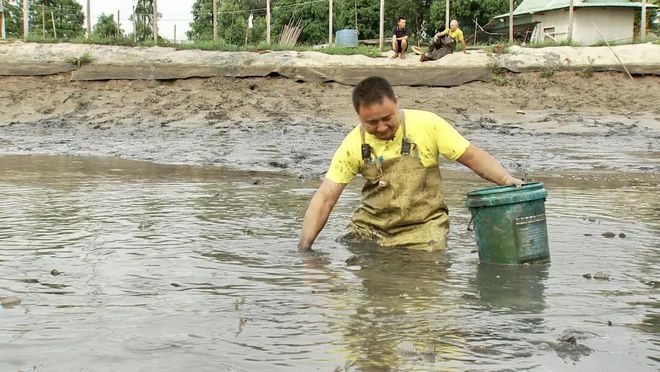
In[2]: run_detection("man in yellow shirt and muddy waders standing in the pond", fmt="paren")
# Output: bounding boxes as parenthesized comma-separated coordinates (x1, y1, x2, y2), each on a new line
(298, 77, 523, 251)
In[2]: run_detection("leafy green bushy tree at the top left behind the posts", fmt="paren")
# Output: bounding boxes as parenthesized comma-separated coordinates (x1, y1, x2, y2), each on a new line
(29, 0, 85, 39)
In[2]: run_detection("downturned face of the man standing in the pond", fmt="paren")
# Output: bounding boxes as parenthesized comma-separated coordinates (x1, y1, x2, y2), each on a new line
(358, 97, 399, 141)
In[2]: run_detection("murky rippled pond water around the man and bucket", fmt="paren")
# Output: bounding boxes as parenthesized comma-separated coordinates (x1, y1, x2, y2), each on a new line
(0, 156, 660, 371)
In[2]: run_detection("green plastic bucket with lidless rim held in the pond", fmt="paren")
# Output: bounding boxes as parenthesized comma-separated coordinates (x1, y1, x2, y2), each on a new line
(465, 182, 550, 265)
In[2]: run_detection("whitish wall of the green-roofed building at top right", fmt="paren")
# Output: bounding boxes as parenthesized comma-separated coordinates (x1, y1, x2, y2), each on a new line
(532, 8, 636, 45)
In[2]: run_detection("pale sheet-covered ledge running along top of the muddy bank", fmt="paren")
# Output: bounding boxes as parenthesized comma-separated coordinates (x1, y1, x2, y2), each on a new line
(0, 42, 660, 87)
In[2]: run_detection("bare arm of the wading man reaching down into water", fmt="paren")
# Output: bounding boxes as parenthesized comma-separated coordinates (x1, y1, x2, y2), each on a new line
(298, 178, 346, 251)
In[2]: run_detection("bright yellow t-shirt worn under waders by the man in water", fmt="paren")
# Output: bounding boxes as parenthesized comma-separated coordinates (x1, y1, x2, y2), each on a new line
(325, 110, 470, 183)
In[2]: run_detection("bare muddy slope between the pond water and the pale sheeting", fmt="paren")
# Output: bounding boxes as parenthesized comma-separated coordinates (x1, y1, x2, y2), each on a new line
(0, 72, 660, 177)
